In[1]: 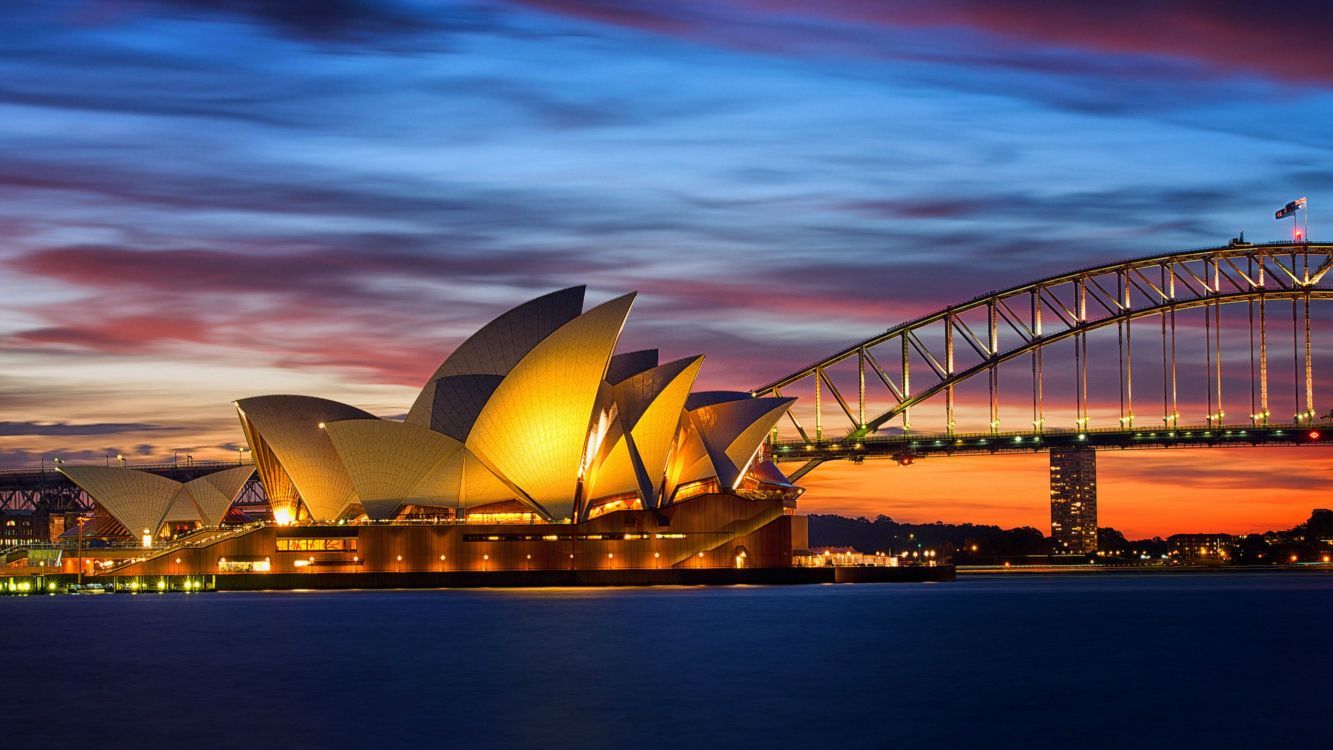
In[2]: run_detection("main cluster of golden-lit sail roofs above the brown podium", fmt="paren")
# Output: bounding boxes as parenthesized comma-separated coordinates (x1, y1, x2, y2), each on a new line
(230, 286, 792, 521)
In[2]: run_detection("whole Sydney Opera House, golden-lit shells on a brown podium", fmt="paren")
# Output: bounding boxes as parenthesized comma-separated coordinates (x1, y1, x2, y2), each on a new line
(51, 286, 805, 575)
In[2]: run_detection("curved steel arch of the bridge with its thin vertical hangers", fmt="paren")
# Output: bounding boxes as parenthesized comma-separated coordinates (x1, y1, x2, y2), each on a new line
(752, 241, 1333, 444)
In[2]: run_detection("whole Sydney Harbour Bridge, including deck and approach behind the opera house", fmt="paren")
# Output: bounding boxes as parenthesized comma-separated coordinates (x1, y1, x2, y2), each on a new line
(0, 240, 1333, 532)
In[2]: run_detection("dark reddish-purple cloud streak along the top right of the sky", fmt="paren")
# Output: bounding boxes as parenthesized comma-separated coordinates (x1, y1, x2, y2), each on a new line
(506, 0, 1333, 84)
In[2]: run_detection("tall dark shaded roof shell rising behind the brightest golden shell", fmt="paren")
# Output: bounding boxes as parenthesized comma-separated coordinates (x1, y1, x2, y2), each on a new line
(407, 286, 585, 431)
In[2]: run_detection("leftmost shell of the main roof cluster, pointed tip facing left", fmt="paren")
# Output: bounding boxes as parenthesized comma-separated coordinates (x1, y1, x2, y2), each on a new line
(236, 396, 375, 521)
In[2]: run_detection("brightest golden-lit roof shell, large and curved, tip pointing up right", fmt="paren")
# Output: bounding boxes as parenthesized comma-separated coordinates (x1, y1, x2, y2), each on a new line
(468, 294, 635, 518)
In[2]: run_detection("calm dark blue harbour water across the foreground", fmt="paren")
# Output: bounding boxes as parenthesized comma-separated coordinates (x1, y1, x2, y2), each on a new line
(0, 573, 1333, 749)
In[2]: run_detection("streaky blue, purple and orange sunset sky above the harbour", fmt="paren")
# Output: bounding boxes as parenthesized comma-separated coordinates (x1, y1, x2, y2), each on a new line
(0, 0, 1333, 537)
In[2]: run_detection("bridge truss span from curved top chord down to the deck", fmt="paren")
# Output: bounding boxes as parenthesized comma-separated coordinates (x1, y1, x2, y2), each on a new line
(752, 242, 1333, 471)
